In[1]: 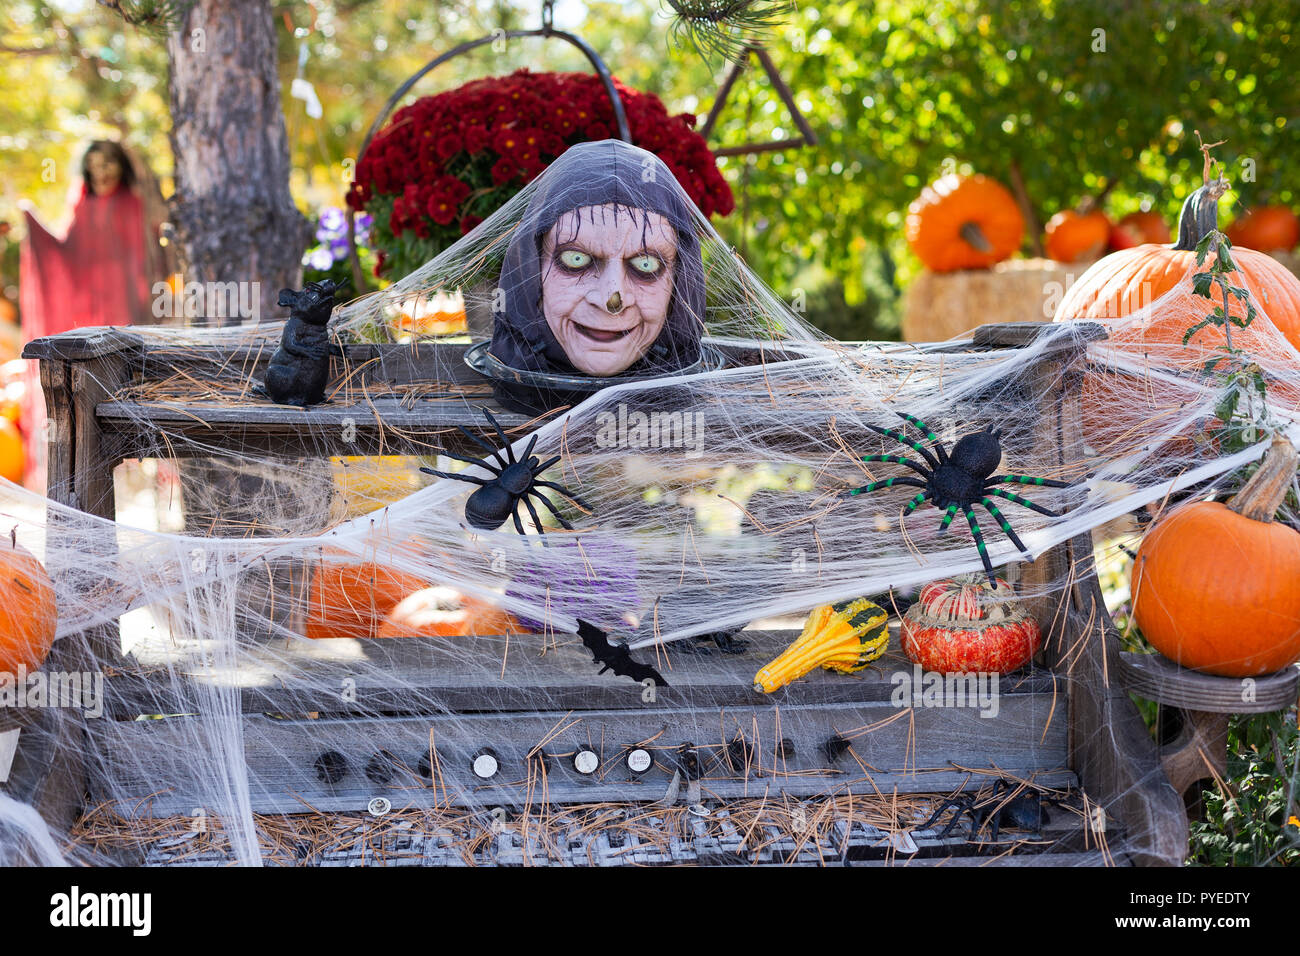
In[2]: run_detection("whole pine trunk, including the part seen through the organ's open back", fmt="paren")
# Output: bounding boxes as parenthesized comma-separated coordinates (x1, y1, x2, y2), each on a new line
(168, 0, 333, 546)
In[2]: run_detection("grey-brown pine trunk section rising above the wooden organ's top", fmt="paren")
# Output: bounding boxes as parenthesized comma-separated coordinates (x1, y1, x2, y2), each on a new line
(168, 0, 311, 325)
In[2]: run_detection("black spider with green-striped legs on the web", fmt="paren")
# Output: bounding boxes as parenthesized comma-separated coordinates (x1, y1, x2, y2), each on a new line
(844, 412, 1073, 587)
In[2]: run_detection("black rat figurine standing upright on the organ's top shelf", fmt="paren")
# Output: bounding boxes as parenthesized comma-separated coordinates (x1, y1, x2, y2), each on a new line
(260, 278, 343, 408)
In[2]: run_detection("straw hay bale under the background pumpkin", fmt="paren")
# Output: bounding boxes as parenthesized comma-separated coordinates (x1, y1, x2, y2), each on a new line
(902, 259, 1092, 342)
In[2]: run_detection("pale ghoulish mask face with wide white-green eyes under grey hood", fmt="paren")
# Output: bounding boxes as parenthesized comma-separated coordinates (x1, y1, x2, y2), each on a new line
(541, 203, 677, 377)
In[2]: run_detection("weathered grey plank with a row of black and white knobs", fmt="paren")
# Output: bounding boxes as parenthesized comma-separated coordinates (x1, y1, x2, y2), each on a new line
(89, 695, 1074, 816)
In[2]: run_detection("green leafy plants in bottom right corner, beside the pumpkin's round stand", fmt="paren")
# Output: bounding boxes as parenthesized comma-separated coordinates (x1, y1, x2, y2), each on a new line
(1188, 708, 1300, 866)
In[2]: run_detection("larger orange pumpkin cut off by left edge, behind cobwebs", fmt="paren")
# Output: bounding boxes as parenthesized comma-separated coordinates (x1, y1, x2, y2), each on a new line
(0, 533, 59, 675)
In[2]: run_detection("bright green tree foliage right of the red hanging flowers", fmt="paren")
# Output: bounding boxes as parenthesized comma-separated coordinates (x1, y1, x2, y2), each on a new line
(696, 0, 1300, 297)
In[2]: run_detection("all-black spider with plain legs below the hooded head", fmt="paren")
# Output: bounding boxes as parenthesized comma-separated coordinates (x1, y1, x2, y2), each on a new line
(420, 408, 592, 535)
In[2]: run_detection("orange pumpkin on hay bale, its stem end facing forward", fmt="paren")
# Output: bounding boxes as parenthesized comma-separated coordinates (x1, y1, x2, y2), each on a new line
(906, 173, 1024, 272)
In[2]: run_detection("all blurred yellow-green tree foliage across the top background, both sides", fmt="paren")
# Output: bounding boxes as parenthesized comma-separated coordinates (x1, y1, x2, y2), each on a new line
(0, 0, 1300, 332)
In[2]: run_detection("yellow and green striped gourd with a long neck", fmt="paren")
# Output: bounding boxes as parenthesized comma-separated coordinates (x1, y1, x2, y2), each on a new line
(754, 597, 889, 693)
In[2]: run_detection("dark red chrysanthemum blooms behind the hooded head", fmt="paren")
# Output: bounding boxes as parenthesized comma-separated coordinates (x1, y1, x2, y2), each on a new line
(347, 70, 735, 277)
